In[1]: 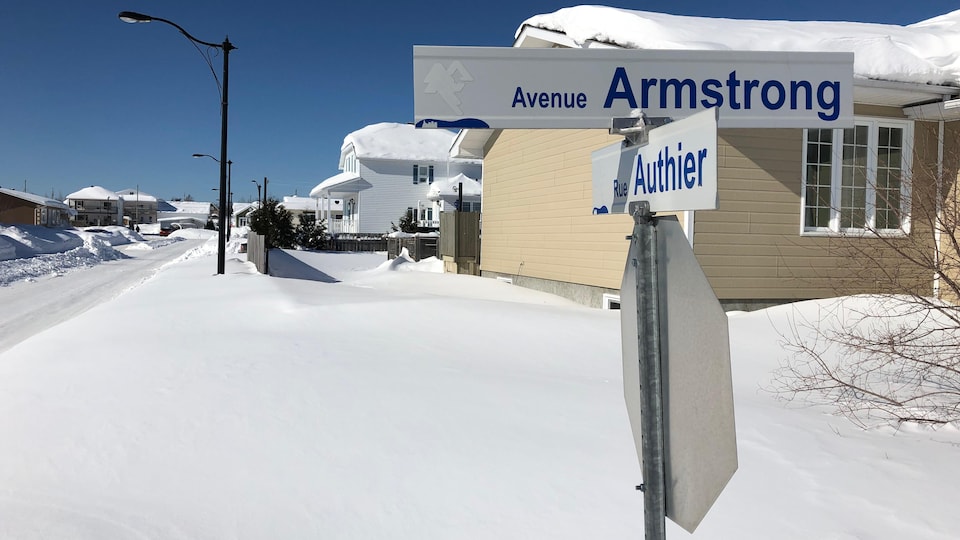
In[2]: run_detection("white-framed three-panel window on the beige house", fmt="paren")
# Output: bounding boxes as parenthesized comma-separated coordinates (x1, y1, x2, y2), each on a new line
(801, 118, 913, 234)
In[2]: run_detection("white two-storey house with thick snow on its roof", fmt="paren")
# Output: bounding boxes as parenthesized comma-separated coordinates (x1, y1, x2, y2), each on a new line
(310, 122, 482, 234)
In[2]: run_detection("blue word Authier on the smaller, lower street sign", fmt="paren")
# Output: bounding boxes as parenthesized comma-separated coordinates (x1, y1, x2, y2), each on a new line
(632, 142, 707, 196)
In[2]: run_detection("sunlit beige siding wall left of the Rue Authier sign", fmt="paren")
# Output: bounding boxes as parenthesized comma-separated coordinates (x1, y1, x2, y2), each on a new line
(481, 130, 633, 289)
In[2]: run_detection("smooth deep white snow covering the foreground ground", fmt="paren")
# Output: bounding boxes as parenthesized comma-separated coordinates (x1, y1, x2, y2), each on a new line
(0, 224, 960, 540)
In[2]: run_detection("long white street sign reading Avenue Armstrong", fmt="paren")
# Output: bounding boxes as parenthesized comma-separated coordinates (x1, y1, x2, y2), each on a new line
(413, 46, 853, 129)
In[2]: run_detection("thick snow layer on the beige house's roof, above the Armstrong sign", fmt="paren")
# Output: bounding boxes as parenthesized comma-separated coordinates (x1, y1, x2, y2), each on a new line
(516, 6, 960, 86)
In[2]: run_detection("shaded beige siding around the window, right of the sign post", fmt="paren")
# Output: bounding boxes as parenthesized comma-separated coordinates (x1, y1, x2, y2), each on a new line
(694, 117, 932, 300)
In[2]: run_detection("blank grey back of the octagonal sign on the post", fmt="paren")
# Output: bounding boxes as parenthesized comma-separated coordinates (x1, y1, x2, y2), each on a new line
(620, 216, 737, 532)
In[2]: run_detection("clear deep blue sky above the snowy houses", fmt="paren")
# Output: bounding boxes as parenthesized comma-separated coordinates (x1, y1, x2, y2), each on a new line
(0, 0, 958, 201)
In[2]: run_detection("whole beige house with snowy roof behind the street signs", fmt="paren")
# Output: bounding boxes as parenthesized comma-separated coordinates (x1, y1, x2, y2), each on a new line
(454, 6, 960, 309)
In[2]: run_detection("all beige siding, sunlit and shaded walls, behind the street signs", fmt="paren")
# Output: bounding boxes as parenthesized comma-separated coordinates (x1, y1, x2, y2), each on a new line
(481, 107, 940, 301)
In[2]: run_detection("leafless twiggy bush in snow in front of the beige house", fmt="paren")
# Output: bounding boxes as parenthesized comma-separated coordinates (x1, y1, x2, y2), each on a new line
(773, 132, 960, 426)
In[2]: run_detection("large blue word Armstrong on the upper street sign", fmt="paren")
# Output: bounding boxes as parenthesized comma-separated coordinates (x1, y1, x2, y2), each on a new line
(604, 66, 840, 121)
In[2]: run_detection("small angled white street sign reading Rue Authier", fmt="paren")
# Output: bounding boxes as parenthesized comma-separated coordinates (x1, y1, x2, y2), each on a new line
(593, 109, 718, 214)
